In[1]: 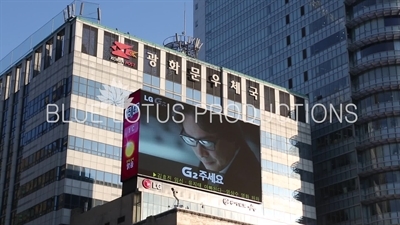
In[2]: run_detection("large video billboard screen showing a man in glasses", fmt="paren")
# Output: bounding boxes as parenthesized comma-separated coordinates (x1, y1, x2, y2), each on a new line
(123, 90, 262, 202)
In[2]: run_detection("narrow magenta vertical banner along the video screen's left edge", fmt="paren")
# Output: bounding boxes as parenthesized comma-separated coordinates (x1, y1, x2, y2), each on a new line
(121, 90, 141, 182)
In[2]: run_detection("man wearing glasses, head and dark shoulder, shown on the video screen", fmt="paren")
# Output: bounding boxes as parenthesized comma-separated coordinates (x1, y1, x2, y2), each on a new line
(175, 104, 261, 191)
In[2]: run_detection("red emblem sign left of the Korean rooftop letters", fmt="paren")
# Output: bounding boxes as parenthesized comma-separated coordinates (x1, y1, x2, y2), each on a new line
(110, 40, 138, 69)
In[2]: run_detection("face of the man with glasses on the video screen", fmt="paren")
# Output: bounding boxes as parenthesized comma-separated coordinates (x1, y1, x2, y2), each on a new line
(181, 115, 236, 172)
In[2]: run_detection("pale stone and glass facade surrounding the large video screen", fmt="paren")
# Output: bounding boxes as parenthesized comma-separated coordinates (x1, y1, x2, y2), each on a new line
(0, 2, 316, 225)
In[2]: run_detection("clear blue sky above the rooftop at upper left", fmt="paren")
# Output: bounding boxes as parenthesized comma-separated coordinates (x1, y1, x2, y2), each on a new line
(0, 0, 193, 59)
